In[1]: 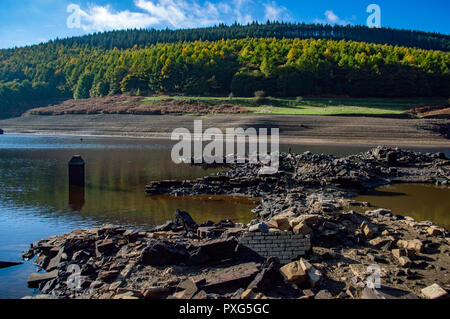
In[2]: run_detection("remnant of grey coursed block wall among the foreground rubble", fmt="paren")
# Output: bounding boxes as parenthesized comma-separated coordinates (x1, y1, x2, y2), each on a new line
(240, 232, 311, 264)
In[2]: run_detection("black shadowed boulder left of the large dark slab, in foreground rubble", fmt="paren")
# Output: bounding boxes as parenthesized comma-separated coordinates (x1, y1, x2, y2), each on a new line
(140, 241, 188, 266)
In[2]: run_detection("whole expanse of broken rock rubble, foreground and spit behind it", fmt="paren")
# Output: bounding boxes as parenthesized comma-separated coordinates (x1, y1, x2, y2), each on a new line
(24, 147, 450, 299)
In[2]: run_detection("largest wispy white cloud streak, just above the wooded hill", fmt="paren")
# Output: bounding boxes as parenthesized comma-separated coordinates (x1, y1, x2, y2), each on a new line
(68, 0, 288, 32)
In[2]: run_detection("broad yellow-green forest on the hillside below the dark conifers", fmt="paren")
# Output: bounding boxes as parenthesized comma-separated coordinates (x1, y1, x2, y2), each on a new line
(0, 25, 450, 116)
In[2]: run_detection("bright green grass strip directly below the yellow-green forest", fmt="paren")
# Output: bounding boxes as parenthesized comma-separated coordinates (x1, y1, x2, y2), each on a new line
(143, 96, 447, 115)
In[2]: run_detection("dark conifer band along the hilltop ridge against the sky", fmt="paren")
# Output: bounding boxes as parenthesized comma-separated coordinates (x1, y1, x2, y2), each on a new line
(30, 21, 450, 51)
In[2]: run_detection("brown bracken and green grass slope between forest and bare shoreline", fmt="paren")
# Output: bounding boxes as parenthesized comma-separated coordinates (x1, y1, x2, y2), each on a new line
(26, 95, 450, 118)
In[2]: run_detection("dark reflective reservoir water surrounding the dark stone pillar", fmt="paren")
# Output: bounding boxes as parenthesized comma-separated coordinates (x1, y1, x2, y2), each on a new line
(0, 134, 449, 298)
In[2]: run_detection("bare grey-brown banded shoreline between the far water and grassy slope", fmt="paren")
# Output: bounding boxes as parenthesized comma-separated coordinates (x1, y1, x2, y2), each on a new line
(0, 114, 450, 148)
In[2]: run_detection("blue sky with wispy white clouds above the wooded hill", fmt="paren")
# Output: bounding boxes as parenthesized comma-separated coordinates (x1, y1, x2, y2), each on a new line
(0, 0, 450, 48)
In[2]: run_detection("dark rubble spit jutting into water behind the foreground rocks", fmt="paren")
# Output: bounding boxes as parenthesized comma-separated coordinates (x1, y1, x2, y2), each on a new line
(146, 147, 450, 197)
